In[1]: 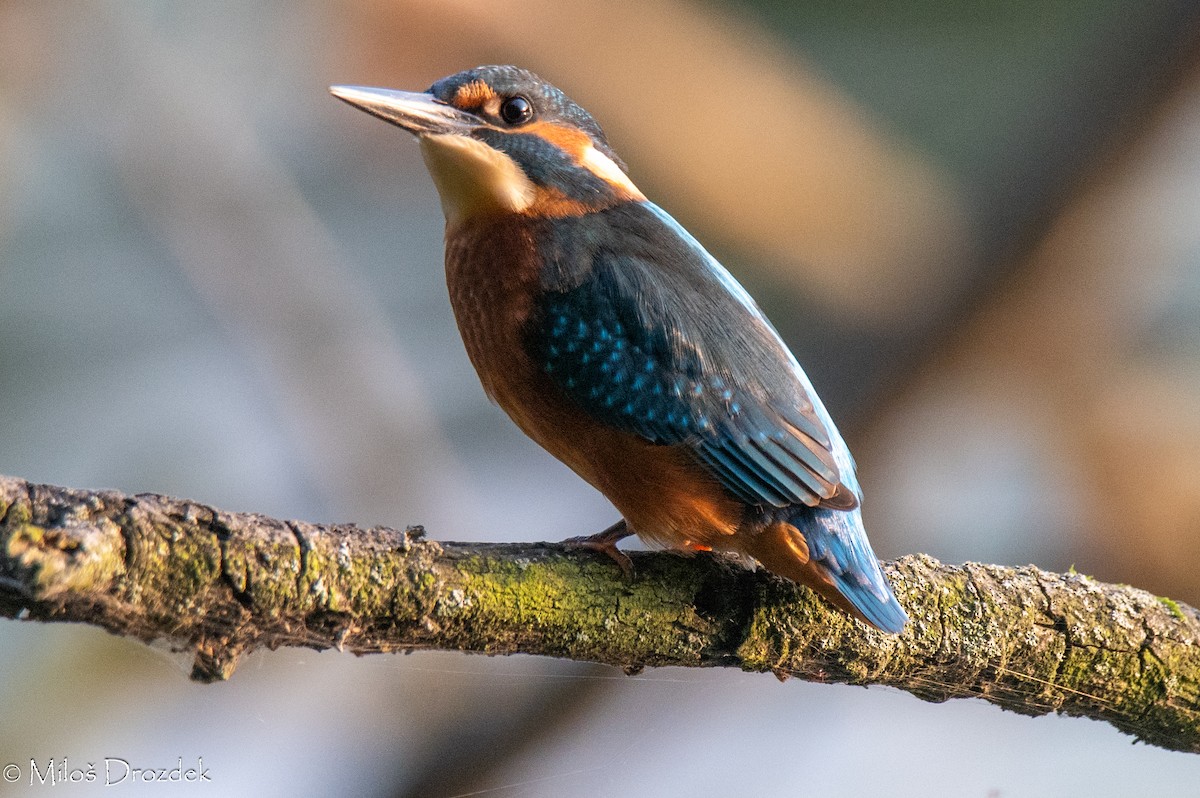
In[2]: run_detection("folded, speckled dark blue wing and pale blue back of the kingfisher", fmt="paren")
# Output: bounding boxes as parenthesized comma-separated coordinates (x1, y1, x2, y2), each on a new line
(526, 203, 858, 509)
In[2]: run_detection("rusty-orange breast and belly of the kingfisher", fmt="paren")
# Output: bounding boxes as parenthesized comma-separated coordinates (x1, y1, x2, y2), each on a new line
(446, 216, 743, 547)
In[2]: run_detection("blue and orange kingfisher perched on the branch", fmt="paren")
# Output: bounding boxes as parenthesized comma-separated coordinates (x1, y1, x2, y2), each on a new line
(330, 66, 907, 632)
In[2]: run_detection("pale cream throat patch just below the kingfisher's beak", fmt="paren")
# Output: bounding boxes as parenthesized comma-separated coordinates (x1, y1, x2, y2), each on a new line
(420, 134, 537, 226)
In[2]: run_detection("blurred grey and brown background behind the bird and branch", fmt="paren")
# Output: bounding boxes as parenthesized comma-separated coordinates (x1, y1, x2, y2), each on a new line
(0, 0, 1200, 798)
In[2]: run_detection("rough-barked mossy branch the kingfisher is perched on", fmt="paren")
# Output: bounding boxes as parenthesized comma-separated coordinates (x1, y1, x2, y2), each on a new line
(0, 476, 1200, 752)
